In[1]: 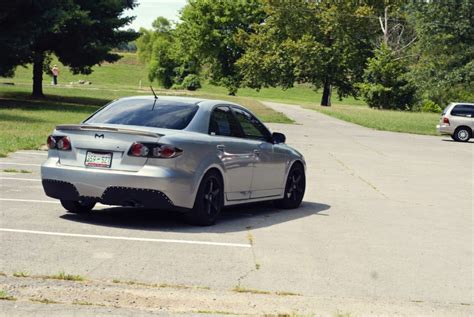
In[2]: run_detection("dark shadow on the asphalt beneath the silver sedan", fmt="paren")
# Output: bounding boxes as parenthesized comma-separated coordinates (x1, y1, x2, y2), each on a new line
(61, 202, 331, 233)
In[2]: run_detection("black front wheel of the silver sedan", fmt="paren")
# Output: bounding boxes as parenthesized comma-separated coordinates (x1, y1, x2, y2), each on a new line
(275, 163, 306, 209)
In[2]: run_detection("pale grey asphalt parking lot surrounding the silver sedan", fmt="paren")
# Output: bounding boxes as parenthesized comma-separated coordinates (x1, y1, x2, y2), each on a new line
(0, 103, 474, 316)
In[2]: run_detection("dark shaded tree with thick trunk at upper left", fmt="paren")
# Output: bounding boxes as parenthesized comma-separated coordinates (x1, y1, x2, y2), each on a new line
(0, 0, 138, 97)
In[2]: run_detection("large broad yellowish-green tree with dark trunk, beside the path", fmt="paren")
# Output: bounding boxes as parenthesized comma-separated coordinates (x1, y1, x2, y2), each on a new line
(237, 0, 376, 106)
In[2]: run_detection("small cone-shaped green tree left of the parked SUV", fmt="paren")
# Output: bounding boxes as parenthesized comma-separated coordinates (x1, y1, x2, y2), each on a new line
(359, 44, 416, 110)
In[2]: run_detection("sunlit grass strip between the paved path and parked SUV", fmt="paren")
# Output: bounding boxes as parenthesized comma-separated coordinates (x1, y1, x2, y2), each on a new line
(305, 105, 440, 135)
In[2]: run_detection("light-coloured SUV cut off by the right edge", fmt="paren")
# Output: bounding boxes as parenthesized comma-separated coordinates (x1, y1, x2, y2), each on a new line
(436, 102, 474, 142)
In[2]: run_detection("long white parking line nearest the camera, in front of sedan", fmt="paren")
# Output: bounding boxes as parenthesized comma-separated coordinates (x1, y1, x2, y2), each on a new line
(0, 228, 252, 248)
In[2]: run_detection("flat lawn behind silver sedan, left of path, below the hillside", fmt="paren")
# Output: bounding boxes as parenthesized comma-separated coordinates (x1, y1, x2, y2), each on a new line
(0, 84, 292, 156)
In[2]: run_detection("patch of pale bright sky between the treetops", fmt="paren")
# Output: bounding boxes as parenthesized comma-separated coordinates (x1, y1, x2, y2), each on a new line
(126, 0, 186, 31)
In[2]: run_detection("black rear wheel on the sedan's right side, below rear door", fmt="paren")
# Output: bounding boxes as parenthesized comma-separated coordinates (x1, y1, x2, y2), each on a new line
(185, 171, 224, 226)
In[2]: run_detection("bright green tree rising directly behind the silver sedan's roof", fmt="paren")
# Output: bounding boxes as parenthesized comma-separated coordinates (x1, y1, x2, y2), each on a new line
(177, 0, 265, 94)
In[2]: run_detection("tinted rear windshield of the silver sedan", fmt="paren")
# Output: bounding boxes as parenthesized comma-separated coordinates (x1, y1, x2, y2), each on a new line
(84, 99, 199, 130)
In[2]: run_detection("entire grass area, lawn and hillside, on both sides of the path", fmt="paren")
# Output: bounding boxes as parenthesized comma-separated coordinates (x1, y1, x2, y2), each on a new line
(0, 53, 439, 156)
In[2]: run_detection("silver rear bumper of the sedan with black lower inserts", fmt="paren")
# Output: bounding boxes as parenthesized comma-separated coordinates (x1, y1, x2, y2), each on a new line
(41, 157, 195, 209)
